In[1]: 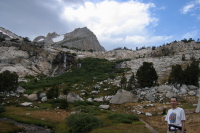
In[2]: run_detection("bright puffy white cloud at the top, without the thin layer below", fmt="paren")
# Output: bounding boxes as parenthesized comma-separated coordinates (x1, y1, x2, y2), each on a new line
(63, 0, 156, 36)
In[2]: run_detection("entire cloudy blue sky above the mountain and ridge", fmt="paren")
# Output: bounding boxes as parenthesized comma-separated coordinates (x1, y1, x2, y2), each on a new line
(0, 0, 200, 51)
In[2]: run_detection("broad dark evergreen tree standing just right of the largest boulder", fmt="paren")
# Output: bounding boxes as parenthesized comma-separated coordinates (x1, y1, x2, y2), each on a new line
(136, 62, 158, 87)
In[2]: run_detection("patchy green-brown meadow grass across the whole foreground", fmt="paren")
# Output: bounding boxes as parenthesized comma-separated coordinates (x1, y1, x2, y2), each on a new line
(0, 95, 200, 133)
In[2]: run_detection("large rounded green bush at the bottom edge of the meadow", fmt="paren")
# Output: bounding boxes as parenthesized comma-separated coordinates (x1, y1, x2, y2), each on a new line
(67, 113, 103, 133)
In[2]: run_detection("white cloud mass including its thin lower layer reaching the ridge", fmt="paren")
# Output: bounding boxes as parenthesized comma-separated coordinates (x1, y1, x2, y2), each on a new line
(58, 0, 173, 49)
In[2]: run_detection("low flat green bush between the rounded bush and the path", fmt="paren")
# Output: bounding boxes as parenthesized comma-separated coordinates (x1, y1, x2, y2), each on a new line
(108, 114, 139, 124)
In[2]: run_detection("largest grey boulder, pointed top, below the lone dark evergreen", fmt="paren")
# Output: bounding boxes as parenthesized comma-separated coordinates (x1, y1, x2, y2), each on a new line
(110, 89, 138, 104)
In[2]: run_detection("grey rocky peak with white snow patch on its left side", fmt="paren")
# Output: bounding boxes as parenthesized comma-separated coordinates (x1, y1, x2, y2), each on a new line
(33, 27, 105, 51)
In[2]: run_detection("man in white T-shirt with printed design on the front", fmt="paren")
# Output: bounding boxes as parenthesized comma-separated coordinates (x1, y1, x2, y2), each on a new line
(165, 97, 186, 133)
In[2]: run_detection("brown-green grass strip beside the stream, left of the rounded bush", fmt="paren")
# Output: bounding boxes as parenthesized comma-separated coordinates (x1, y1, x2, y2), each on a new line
(0, 106, 68, 132)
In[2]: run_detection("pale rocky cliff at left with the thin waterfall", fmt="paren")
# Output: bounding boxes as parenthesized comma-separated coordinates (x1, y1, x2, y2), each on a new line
(0, 43, 76, 77)
